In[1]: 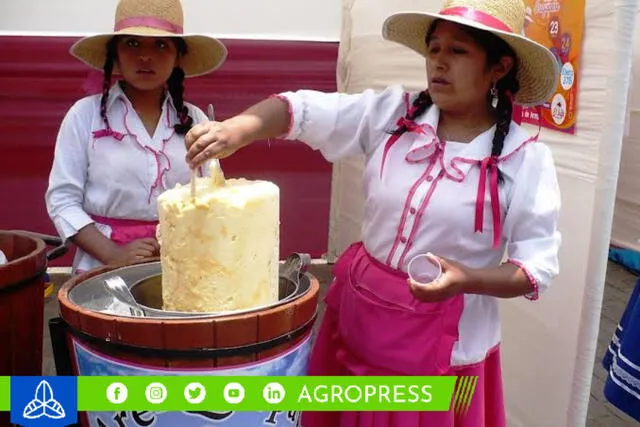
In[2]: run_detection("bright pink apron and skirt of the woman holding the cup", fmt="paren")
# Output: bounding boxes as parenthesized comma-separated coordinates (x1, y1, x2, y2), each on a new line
(302, 243, 506, 427)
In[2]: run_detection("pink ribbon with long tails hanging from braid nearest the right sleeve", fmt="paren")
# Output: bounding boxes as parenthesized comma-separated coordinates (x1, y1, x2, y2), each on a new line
(475, 156, 502, 248)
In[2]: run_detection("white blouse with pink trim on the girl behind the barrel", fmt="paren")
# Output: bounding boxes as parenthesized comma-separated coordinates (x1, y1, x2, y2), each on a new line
(45, 84, 208, 271)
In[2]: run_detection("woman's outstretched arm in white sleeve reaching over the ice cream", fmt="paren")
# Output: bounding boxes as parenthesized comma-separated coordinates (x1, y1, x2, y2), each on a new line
(185, 86, 409, 168)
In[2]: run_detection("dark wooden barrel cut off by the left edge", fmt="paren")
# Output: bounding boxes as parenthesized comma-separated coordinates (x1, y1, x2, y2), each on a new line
(0, 230, 66, 425)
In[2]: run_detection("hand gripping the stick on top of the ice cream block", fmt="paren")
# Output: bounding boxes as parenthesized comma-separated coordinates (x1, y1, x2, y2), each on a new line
(185, 122, 250, 169)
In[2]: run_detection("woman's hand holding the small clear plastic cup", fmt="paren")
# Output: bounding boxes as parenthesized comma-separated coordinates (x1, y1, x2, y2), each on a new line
(407, 256, 472, 302)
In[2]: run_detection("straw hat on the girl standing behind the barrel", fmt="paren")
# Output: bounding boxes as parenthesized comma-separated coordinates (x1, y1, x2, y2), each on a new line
(70, 0, 227, 77)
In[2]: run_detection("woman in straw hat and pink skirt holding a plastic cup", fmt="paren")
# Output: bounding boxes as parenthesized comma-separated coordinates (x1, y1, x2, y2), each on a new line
(186, 0, 560, 427)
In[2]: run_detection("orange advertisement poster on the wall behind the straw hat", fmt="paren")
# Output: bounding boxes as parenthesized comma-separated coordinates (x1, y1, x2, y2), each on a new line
(522, 0, 585, 134)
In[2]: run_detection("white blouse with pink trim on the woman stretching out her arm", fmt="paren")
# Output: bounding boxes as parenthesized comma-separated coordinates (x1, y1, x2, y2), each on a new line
(278, 86, 561, 366)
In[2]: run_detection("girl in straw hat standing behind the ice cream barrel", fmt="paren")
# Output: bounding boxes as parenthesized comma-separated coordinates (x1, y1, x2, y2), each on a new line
(46, 0, 227, 272)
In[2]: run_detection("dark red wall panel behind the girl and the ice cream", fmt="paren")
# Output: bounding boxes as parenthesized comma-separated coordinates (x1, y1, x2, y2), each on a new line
(0, 37, 338, 265)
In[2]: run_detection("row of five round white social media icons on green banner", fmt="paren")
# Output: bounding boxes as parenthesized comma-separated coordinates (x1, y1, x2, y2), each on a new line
(107, 382, 286, 405)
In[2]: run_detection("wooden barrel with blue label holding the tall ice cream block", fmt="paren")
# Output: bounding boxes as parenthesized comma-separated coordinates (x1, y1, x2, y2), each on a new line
(52, 263, 320, 427)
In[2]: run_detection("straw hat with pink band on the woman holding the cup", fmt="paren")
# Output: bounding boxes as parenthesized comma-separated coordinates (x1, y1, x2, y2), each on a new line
(382, 0, 560, 106)
